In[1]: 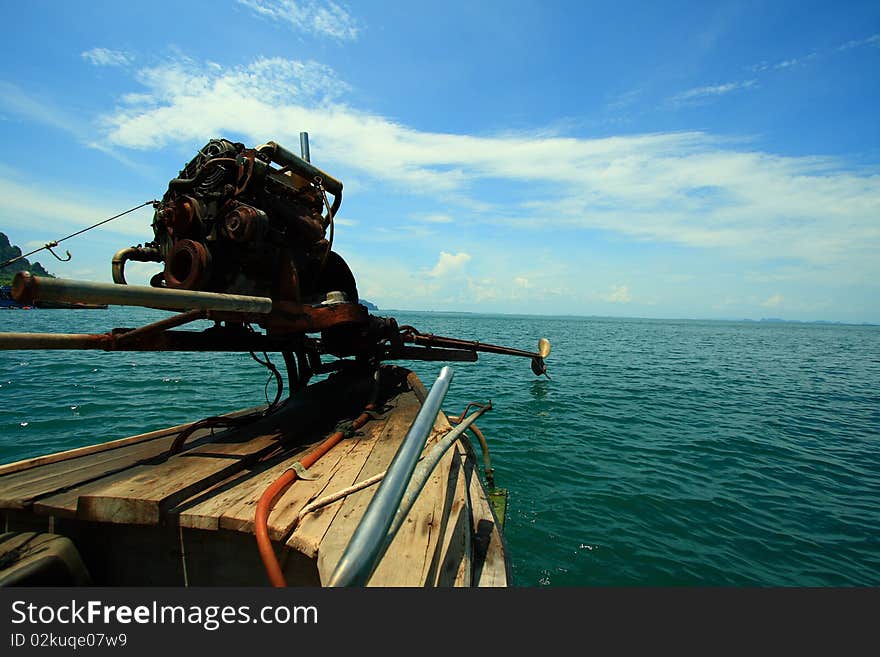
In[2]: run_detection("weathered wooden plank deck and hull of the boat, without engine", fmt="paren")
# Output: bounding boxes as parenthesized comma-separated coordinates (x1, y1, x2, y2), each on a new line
(0, 366, 509, 586)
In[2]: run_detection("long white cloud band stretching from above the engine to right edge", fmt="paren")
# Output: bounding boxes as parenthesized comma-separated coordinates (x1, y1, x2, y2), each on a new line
(84, 53, 880, 277)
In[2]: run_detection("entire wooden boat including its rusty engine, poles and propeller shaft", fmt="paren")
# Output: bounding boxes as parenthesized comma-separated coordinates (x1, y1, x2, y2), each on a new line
(0, 133, 550, 586)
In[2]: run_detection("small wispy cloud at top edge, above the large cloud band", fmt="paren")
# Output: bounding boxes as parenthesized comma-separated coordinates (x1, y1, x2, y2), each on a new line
(238, 0, 361, 41)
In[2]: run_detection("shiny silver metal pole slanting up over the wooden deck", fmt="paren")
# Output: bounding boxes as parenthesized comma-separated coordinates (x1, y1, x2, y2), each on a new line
(329, 367, 452, 586)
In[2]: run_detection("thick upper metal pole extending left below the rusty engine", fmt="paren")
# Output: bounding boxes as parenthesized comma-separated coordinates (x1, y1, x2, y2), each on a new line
(12, 272, 272, 315)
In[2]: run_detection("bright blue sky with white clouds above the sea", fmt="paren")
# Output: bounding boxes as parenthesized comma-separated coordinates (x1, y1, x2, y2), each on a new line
(0, 0, 880, 323)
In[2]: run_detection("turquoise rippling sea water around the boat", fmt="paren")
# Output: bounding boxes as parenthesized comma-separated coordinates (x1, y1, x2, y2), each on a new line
(0, 308, 880, 586)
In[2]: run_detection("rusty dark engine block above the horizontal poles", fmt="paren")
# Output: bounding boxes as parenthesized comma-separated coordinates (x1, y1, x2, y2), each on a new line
(113, 139, 358, 303)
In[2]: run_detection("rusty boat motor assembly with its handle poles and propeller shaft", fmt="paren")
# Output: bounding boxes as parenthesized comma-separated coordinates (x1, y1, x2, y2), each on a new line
(0, 133, 550, 380)
